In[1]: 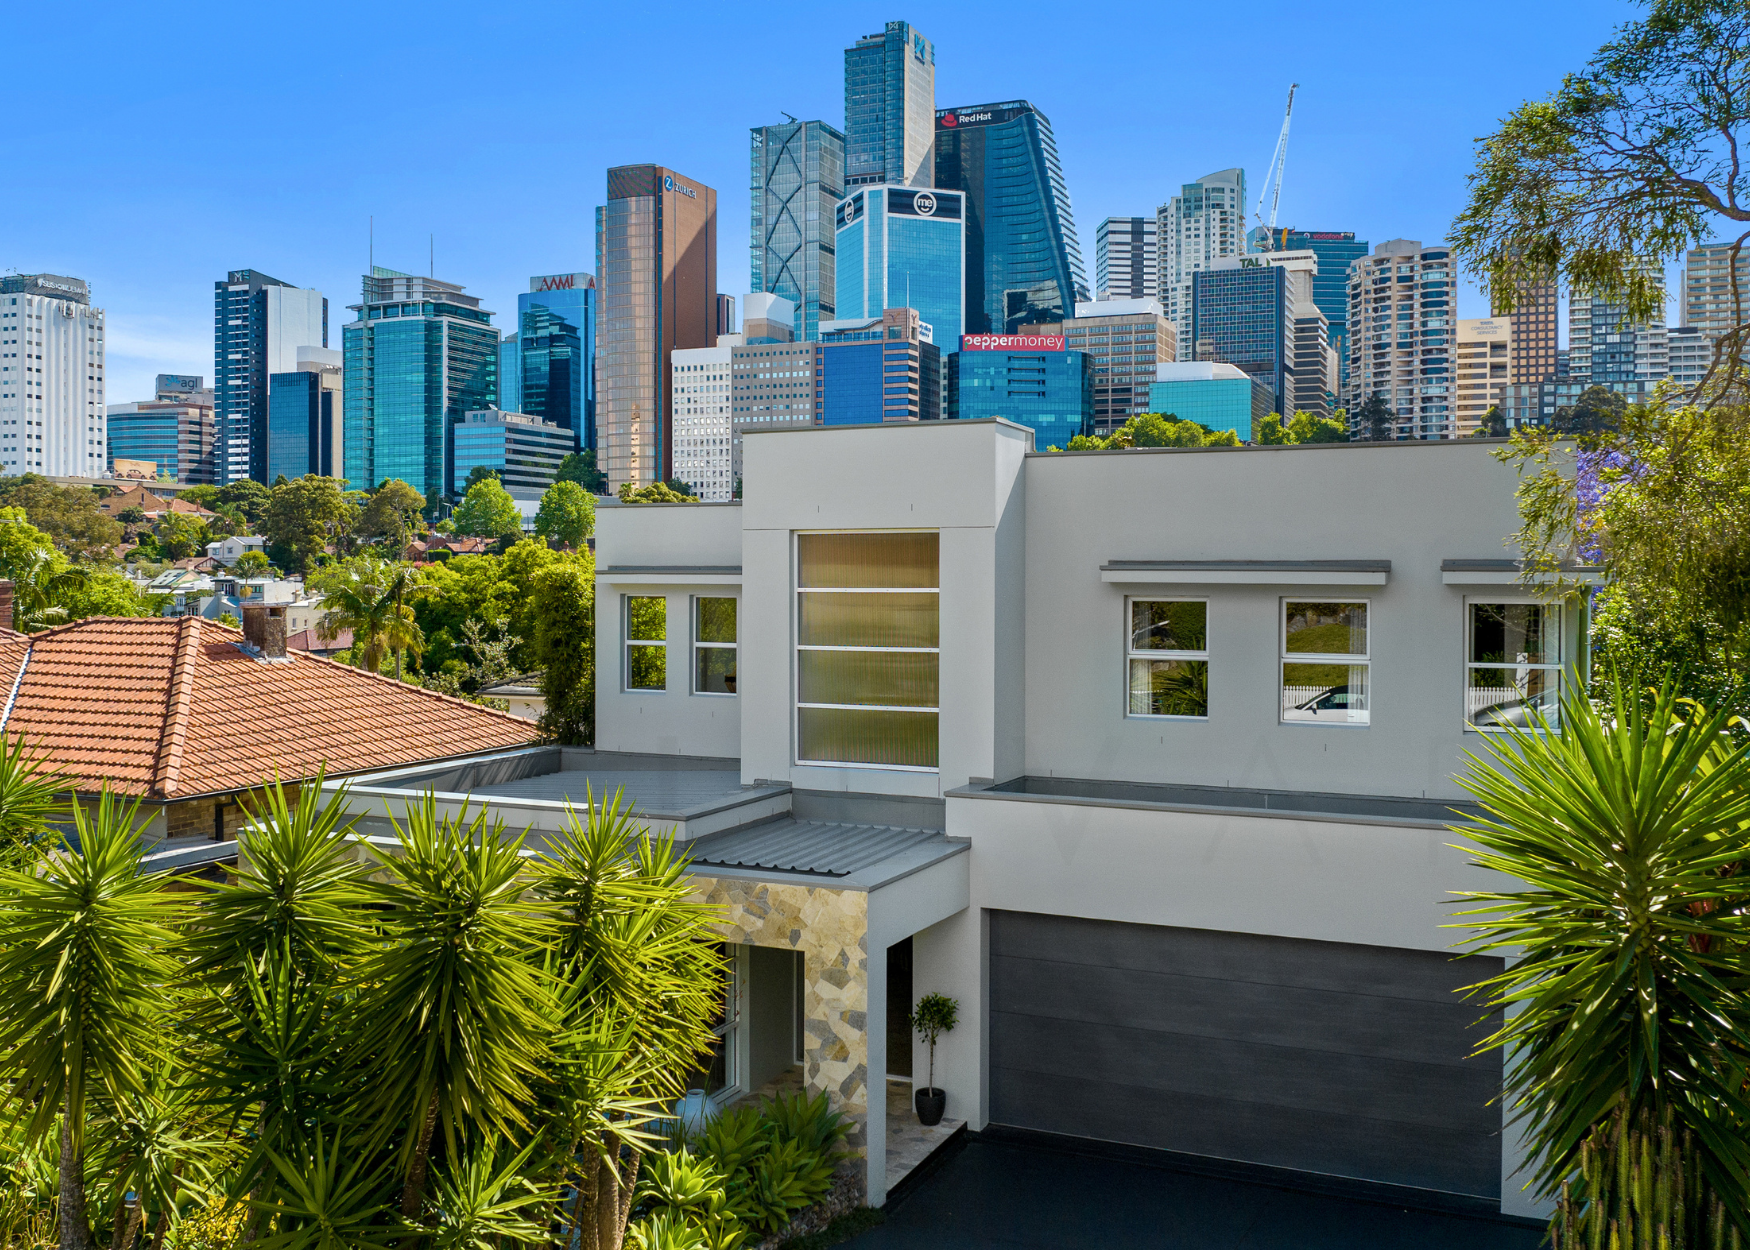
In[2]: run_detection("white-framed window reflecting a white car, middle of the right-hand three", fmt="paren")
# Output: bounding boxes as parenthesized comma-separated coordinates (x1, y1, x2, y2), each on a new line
(1279, 599, 1372, 725)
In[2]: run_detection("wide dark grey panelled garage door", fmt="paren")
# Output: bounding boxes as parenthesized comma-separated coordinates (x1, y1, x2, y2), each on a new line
(991, 912, 1502, 1197)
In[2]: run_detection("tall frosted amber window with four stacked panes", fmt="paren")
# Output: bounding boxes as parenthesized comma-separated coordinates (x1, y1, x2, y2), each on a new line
(796, 532, 942, 769)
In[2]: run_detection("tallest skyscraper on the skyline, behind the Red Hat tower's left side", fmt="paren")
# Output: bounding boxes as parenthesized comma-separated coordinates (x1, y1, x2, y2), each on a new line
(845, 21, 936, 187)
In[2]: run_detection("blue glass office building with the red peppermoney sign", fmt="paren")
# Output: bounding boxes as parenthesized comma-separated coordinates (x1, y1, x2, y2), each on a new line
(949, 343, 1094, 452)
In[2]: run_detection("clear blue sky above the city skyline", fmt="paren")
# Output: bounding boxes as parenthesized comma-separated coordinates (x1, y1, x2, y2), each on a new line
(13, 0, 1638, 403)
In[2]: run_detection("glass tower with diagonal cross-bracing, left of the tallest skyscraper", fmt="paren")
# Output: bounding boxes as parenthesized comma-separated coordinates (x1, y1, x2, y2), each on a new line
(749, 121, 845, 340)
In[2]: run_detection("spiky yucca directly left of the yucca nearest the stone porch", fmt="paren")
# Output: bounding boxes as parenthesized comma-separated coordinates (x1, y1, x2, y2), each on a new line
(359, 795, 553, 1218)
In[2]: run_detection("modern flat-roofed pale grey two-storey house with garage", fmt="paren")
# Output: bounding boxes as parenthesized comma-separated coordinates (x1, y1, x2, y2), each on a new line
(330, 420, 1584, 1215)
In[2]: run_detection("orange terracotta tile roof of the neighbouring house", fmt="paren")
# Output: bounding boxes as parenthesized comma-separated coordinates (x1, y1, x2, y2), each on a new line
(0, 616, 534, 798)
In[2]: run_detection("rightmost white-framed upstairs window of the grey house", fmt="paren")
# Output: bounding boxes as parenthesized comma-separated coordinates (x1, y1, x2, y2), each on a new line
(1465, 597, 1561, 732)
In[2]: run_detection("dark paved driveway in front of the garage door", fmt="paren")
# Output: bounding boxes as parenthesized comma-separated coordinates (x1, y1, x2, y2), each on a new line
(847, 1138, 1542, 1250)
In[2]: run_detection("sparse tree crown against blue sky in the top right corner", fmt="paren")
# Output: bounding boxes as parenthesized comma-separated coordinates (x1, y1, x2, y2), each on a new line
(1451, 0, 1750, 385)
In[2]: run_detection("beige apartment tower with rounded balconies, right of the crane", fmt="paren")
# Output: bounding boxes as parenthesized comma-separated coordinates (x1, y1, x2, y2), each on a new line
(1344, 238, 1456, 439)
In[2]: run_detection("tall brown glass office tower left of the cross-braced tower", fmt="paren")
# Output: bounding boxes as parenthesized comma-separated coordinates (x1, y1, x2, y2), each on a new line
(595, 165, 718, 490)
